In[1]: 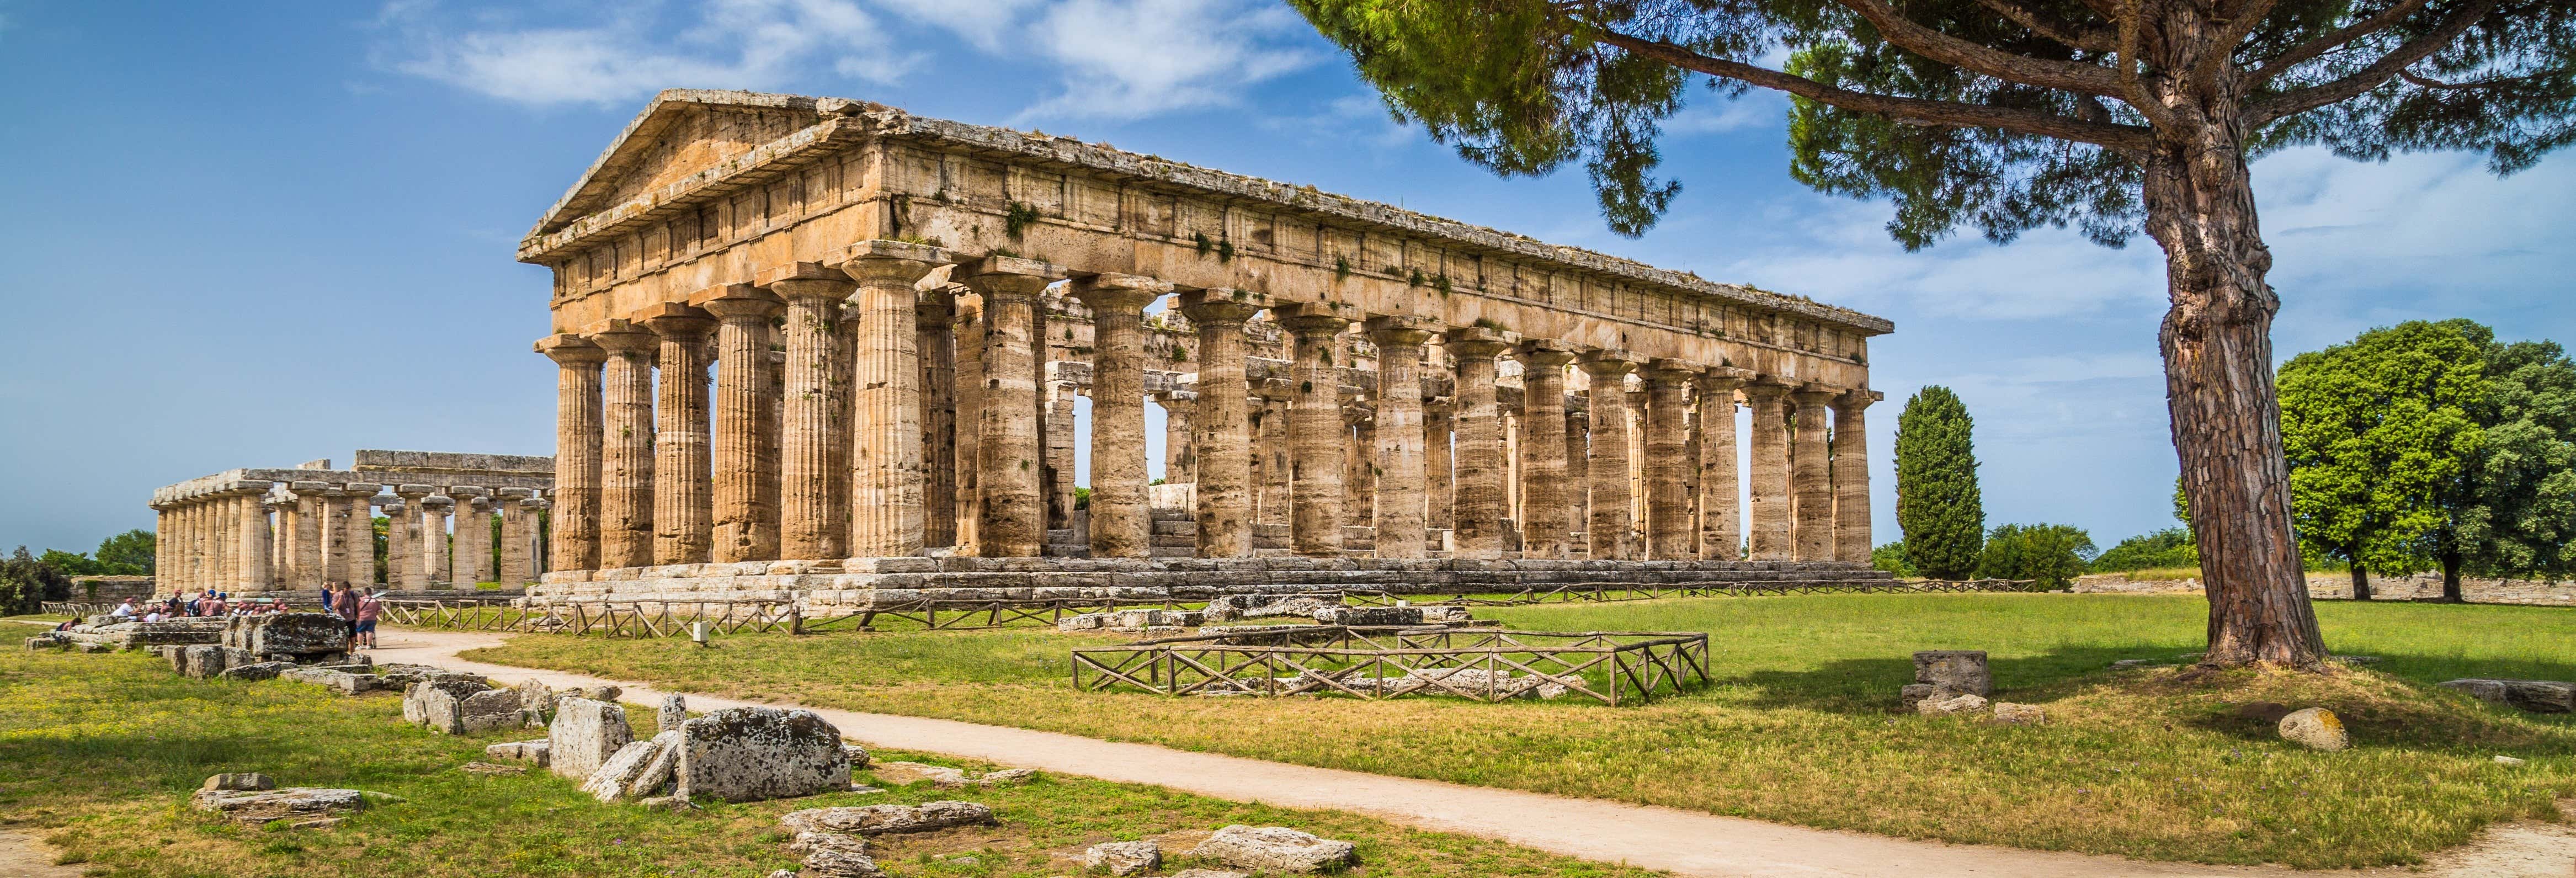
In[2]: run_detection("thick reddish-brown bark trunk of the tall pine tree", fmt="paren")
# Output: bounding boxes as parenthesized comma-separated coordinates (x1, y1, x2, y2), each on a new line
(2143, 113, 2326, 667)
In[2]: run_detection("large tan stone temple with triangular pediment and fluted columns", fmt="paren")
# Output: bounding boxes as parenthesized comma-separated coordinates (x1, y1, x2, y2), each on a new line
(518, 90, 1893, 605)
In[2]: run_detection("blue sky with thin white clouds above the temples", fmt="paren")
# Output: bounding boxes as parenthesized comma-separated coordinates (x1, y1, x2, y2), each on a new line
(0, 0, 2576, 551)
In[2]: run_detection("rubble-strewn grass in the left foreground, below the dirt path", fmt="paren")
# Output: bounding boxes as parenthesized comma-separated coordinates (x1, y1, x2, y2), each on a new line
(0, 651, 1649, 878)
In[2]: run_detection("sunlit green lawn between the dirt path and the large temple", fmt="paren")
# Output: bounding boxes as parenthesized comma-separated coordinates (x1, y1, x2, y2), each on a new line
(471, 595, 2576, 868)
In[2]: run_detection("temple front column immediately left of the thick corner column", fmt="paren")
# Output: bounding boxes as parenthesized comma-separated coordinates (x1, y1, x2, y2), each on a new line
(760, 263, 858, 561)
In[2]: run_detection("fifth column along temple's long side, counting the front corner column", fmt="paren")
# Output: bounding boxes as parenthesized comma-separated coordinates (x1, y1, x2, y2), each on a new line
(1273, 301, 1353, 558)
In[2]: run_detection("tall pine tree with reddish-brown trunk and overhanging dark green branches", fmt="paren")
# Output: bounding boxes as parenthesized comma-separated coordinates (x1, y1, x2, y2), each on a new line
(1291, 0, 2576, 667)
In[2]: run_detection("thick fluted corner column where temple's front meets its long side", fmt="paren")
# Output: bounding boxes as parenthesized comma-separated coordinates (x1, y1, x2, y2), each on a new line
(834, 240, 956, 558)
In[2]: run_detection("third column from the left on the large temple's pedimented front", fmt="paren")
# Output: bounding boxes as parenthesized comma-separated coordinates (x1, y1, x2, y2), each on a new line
(636, 301, 716, 564)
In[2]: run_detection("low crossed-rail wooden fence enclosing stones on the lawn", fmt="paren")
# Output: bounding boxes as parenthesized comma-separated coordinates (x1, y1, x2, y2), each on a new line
(1072, 626, 1708, 705)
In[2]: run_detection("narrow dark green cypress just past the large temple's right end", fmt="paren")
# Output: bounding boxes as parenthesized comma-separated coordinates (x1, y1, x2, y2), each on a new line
(1896, 384, 1986, 579)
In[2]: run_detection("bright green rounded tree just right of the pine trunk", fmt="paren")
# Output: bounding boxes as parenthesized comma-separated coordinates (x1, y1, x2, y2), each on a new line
(2280, 320, 2486, 600)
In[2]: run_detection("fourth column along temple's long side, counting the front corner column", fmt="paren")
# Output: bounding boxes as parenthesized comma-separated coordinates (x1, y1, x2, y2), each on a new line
(1180, 289, 1270, 558)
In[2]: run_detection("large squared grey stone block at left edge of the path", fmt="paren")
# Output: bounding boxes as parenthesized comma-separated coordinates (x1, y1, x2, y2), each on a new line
(678, 708, 850, 801)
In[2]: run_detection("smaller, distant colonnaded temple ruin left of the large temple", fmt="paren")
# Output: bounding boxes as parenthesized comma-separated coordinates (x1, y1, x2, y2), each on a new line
(152, 448, 554, 595)
